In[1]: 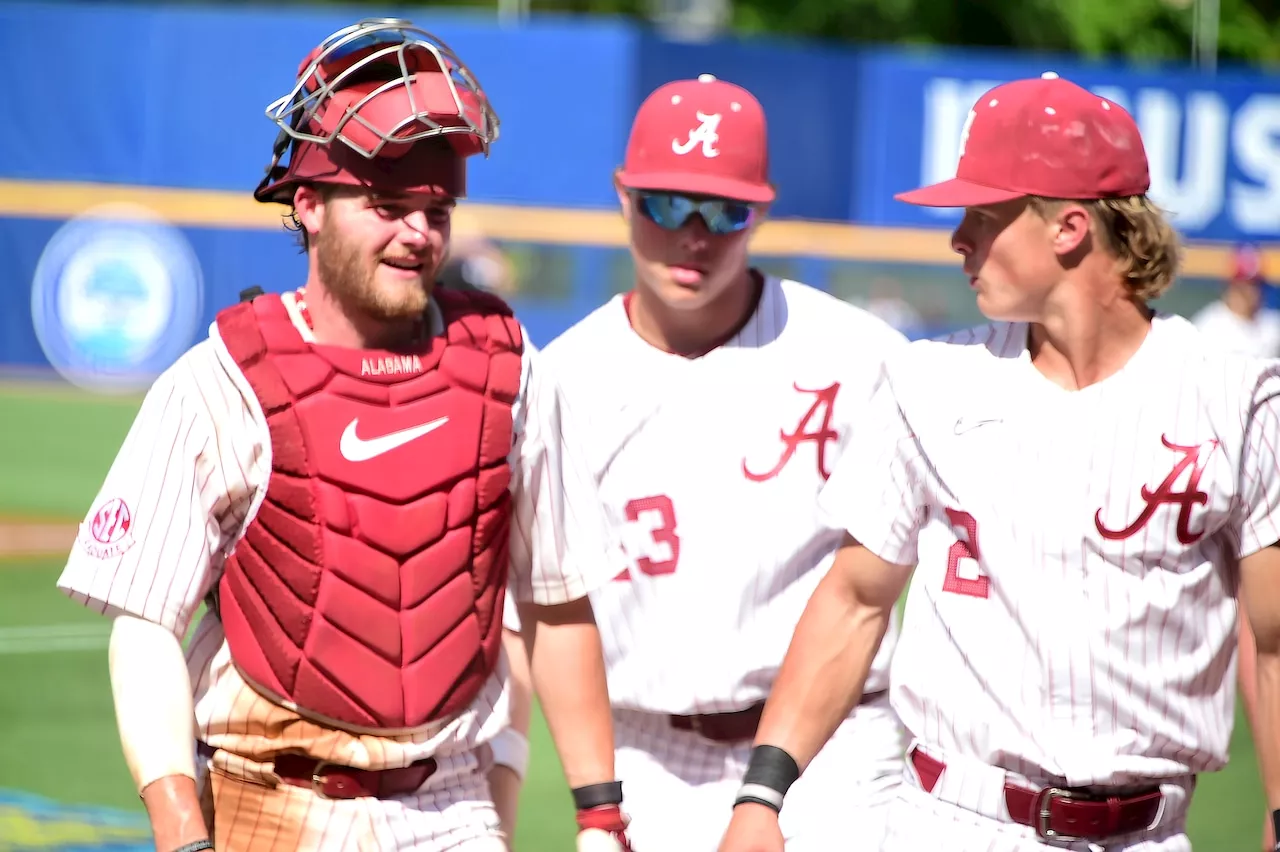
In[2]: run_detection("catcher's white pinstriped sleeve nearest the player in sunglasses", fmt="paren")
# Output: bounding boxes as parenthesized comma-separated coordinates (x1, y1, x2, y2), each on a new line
(511, 337, 621, 603)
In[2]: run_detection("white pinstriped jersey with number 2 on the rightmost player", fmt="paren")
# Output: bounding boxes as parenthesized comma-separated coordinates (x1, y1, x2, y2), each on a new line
(822, 315, 1280, 784)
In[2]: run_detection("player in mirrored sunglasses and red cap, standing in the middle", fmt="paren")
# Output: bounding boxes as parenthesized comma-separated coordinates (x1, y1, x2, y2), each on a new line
(504, 74, 906, 852)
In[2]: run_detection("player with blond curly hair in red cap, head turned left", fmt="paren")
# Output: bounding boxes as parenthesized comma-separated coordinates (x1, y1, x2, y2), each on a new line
(721, 73, 1280, 852)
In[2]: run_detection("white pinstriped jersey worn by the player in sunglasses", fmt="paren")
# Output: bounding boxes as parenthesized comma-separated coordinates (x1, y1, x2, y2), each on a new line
(508, 279, 905, 714)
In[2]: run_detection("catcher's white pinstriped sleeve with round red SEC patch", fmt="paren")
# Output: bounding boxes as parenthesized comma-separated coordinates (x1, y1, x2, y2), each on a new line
(58, 350, 254, 638)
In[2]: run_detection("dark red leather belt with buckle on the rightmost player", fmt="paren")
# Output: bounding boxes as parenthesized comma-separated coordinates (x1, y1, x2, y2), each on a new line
(911, 748, 1161, 842)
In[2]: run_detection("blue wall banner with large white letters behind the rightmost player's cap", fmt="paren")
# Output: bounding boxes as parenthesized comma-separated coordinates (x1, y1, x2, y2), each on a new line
(849, 51, 1280, 242)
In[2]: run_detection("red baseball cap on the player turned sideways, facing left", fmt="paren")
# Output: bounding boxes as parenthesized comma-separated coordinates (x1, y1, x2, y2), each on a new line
(893, 72, 1151, 207)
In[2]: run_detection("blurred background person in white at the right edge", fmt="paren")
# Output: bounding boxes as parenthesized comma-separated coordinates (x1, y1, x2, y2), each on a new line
(1192, 246, 1280, 358)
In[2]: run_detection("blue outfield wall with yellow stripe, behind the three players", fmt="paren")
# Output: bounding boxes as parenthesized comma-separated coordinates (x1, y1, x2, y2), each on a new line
(0, 1, 1280, 381)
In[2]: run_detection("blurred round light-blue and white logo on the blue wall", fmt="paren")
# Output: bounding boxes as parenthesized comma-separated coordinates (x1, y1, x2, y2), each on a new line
(31, 205, 204, 393)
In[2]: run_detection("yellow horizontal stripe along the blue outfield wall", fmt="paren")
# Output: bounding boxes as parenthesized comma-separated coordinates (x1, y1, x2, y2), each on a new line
(0, 180, 1280, 281)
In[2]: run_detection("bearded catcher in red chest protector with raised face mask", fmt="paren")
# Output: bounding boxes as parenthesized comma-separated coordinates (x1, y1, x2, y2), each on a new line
(58, 19, 627, 852)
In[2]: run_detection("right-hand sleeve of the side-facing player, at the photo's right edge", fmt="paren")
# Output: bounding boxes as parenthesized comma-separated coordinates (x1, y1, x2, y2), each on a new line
(1239, 362, 1280, 559)
